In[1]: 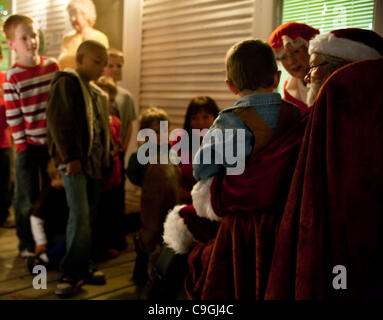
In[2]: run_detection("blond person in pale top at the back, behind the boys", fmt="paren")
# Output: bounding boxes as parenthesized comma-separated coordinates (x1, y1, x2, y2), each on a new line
(59, 0, 109, 69)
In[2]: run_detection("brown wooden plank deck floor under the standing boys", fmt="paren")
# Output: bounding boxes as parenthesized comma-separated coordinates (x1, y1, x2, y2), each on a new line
(0, 228, 148, 300)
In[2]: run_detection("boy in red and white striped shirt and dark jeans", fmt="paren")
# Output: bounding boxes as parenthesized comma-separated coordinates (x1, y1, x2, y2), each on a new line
(4, 15, 59, 258)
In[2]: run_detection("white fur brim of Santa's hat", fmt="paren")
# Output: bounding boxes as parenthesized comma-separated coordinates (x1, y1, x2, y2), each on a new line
(309, 33, 382, 61)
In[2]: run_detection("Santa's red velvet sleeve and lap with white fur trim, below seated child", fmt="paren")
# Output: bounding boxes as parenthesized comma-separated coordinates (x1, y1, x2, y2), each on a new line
(163, 103, 306, 300)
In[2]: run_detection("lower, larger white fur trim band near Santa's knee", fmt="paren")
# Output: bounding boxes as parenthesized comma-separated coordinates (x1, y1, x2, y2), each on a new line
(162, 205, 197, 254)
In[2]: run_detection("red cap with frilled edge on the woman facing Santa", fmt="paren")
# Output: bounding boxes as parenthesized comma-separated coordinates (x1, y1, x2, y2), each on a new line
(269, 22, 319, 58)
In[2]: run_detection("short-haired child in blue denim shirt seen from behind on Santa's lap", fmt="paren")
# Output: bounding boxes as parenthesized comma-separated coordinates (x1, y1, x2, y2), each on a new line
(193, 40, 300, 181)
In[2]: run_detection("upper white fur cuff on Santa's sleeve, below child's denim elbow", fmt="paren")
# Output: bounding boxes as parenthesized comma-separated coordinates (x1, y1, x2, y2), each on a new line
(191, 177, 222, 221)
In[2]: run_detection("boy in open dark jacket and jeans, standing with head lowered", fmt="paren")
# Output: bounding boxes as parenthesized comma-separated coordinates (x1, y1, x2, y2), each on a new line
(47, 40, 110, 296)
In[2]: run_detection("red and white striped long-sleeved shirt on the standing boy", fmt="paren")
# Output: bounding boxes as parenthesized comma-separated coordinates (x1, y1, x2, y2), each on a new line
(4, 57, 59, 152)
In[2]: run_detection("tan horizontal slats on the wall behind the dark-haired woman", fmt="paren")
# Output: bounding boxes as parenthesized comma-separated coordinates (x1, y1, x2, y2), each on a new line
(139, 0, 254, 128)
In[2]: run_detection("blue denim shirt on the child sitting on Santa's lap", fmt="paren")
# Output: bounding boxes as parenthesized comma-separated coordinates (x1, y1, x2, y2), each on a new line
(193, 93, 282, 180)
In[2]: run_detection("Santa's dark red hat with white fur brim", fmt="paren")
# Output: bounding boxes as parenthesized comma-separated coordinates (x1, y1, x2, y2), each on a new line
(308, 28, 383, 61)
